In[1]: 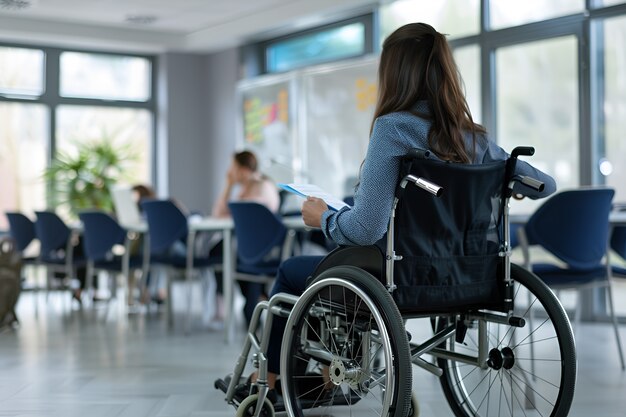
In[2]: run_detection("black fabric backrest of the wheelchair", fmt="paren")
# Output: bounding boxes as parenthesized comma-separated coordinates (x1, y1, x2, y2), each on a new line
(393, 153, 507, 314)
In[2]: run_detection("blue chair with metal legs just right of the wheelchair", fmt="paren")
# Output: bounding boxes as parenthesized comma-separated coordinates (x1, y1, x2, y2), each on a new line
(519, 188, 624, 369)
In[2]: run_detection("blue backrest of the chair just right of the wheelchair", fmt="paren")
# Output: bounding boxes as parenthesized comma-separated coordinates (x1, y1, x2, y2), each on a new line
(524, 188, 615, 269)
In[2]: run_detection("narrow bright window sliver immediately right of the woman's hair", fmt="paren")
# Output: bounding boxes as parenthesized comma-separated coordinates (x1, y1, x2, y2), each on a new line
(454, 45, 482, 123)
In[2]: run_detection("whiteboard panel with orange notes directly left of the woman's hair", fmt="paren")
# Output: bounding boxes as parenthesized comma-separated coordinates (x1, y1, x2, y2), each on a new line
(303, 59, 378, 197)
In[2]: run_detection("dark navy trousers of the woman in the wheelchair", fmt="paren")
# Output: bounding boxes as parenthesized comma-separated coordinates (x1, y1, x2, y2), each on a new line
(267, 256, 324, 374)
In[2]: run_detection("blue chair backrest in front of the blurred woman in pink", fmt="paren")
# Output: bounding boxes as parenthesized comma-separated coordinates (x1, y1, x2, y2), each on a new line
(228, 202, 287, 265)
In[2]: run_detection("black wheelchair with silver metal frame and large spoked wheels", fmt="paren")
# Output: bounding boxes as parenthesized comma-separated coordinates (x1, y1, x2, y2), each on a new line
(216, 147, 577, 417)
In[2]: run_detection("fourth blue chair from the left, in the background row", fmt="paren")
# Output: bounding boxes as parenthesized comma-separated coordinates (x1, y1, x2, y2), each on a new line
(141, 200, 221, 332)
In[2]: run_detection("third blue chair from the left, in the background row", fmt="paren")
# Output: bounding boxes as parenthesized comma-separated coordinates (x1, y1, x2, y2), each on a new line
(78, 210, 142, 303)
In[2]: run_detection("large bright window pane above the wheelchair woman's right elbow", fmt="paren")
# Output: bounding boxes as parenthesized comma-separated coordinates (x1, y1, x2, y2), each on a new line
(496, 36, 579, 213)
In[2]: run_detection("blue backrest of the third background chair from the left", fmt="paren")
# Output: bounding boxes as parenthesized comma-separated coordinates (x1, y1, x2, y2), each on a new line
(78, 211, 126, 261)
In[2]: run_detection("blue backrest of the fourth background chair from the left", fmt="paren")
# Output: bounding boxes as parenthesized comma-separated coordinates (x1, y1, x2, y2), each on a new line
(141, 200, 189, 254)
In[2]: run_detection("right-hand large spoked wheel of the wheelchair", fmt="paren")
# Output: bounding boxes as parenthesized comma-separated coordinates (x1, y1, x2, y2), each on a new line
(438, 264, 576, 417)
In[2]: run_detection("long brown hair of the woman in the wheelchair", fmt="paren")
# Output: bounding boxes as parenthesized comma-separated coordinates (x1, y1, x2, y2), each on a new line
(372, 23, 485, 163)
